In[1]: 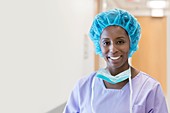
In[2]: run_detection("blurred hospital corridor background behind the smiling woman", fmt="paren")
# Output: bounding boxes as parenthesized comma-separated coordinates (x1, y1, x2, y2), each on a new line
(0, 0, 170, 113)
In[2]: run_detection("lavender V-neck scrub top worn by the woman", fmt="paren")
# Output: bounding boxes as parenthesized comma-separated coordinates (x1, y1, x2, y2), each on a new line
(63, 72, 168, 113)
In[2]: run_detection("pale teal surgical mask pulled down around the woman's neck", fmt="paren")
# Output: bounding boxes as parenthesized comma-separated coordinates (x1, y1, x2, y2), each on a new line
(96, 68, 131, 84)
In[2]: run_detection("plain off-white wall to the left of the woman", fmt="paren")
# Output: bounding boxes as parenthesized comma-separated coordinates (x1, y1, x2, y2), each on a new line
(0, 0, 94, 113)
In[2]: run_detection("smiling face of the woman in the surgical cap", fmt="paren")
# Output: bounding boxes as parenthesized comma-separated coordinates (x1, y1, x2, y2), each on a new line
(100, 26, 130, 72)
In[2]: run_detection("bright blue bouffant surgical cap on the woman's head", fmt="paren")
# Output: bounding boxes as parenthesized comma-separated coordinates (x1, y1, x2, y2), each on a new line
(89, 9, 141, 57)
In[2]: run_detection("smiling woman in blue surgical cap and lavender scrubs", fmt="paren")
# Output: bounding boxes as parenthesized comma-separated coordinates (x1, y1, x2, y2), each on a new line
(63, 9, 168, 113)
